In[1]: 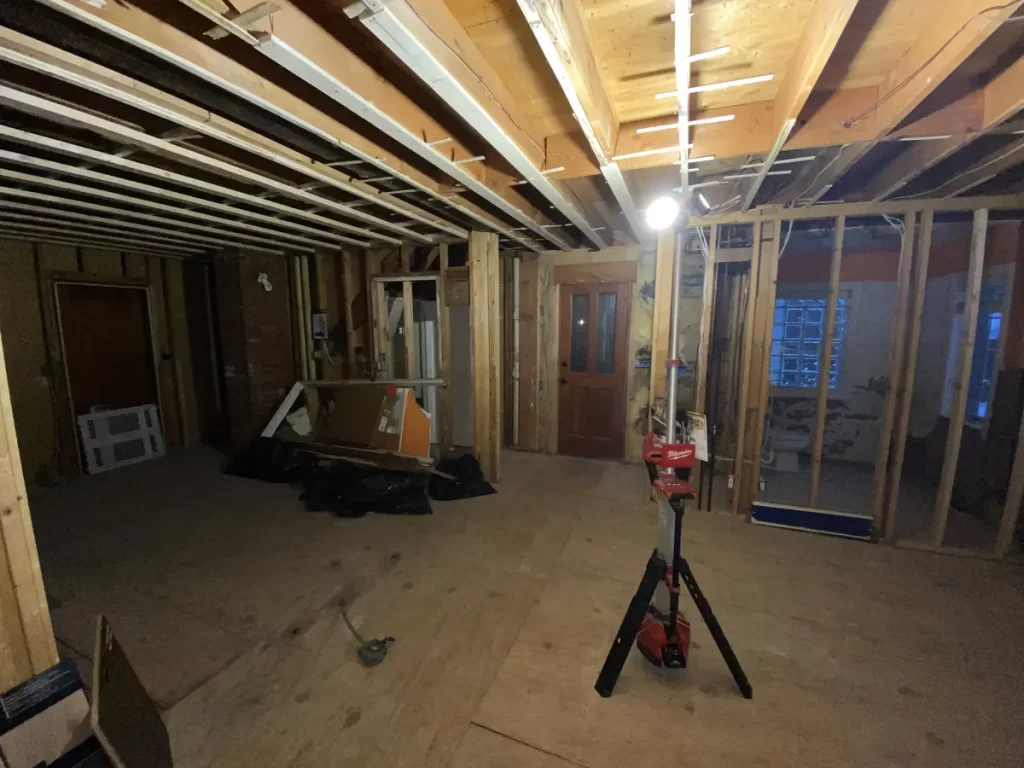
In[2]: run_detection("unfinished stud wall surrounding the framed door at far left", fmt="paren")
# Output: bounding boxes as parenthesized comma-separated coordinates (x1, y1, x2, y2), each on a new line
(0, 240, 198, 483)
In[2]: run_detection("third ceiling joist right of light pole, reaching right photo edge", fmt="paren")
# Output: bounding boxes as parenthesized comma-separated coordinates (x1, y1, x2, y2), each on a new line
(862, 56, 1024, 200)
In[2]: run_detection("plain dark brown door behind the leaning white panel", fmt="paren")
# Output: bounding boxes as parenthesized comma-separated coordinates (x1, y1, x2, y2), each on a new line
(57, 283, 157, 417)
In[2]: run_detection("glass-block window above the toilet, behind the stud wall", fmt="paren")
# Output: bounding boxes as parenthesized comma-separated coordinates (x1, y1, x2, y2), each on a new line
(770, 296, 849, 389)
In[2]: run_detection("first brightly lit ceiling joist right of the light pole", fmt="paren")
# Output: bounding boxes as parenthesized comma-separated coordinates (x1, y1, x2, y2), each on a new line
(741, 0, 859, 211)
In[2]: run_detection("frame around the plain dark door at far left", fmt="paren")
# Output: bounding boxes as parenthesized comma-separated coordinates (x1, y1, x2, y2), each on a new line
(40, 271, 167, 474)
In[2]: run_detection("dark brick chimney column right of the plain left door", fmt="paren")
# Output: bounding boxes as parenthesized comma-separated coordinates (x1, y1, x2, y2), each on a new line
(216, 251, 296, 449)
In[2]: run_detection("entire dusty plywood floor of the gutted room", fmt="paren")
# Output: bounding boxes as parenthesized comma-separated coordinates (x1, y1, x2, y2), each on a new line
(28, 453, 1024, 768)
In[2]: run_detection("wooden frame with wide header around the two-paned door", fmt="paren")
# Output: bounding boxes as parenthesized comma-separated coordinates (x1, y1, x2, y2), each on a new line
(542, 259, 639, 461)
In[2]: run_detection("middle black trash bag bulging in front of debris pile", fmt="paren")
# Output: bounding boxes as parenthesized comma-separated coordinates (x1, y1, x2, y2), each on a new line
(300, 462, 433, 517)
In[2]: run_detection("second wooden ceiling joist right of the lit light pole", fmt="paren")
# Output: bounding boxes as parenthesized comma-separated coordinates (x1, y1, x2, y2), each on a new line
(790, 0, 1024, 203)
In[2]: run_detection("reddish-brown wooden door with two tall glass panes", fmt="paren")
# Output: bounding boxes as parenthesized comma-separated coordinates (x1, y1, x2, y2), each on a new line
(558, 283, 630, 459)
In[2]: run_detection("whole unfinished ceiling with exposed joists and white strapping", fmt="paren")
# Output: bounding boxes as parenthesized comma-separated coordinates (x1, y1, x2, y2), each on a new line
(0, 0, 1024, 253)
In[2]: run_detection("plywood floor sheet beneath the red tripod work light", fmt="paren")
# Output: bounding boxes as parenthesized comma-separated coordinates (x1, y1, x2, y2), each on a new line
(474, 495, 1024, 768)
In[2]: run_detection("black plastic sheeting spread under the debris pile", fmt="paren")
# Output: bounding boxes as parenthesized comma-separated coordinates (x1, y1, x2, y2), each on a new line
(224, 437, 497, 517)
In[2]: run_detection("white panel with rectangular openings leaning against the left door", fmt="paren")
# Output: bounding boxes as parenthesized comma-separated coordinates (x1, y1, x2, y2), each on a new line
(78, 406, 166, 475)
